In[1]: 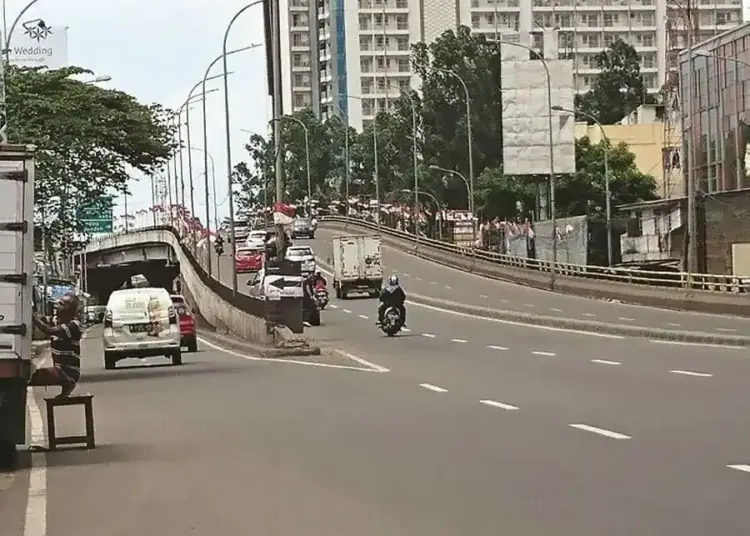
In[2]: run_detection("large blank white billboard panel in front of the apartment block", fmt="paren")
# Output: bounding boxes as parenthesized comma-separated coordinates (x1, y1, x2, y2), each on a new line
(502, 60, 576, 175)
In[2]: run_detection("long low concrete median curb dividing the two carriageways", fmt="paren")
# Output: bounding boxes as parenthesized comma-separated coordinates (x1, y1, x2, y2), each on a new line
(407, 293, 750, 347)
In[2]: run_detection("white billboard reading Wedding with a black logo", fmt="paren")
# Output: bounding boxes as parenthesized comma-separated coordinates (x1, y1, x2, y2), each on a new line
(9, 21, 68, 69)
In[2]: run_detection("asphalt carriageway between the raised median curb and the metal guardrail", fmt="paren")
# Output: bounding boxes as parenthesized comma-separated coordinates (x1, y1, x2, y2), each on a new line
(313, 229, 750, 335)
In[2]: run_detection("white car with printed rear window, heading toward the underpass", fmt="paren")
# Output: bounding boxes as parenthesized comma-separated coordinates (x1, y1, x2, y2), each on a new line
(102, 287, 182, 369)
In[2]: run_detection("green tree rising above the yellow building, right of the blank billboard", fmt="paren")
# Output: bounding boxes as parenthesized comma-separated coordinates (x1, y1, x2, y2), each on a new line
(576, 39, 653, 125)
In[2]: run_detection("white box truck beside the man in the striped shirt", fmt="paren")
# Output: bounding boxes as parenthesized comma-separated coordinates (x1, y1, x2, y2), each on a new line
(0, 145, 35, 466)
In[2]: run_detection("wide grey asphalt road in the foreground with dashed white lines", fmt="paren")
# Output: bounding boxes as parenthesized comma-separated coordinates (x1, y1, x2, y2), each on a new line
(0, 255, 750, 536)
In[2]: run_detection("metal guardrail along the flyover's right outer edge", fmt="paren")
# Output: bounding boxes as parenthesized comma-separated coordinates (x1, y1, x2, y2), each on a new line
(321, 216, 750, 294)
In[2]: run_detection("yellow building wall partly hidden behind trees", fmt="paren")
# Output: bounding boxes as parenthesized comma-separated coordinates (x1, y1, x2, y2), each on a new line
(575, 122, 684, 198)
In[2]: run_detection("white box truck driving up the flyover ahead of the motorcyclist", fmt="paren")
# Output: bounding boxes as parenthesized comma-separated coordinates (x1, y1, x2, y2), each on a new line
(333, 235, 383, 299)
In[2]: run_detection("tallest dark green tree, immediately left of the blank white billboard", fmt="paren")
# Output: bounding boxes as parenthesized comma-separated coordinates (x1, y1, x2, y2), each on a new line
(412, 26, 503, 206)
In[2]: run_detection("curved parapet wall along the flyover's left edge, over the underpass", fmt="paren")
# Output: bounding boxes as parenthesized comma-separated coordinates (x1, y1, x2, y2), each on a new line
(87, 225, 277, 319)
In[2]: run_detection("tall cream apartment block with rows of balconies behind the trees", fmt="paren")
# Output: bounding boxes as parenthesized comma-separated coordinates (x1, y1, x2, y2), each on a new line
(280, 0, 742, 128)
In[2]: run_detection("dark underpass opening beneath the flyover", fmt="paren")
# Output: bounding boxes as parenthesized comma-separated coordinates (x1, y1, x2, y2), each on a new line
(88, 261, 180, 305)
